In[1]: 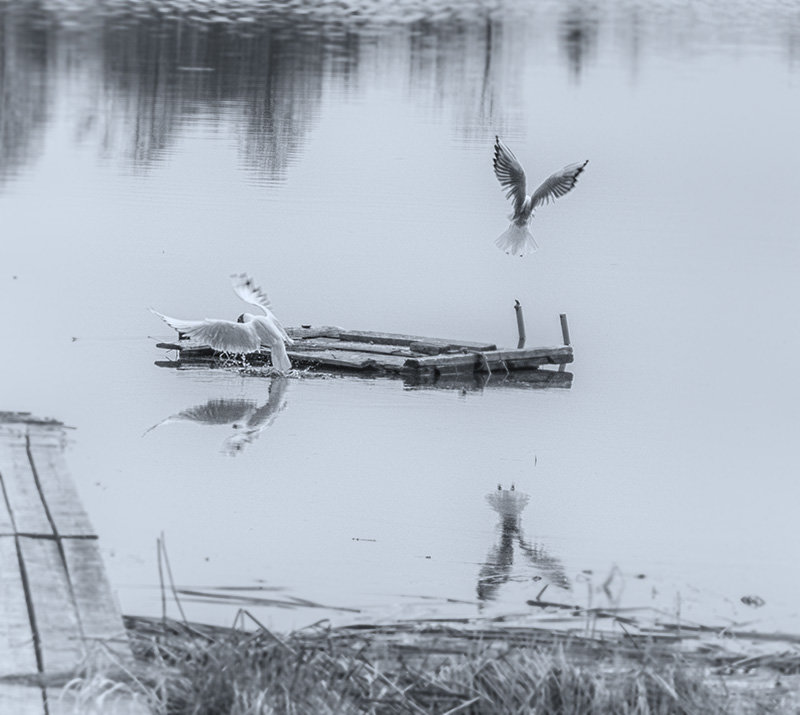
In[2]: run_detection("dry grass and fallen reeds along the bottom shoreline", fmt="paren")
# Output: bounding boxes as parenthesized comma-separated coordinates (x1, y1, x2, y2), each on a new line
(62, 610, 800, 715)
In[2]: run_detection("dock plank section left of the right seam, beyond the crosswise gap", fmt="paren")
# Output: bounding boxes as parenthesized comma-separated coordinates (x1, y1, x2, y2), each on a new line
(0, 424, 53, 534)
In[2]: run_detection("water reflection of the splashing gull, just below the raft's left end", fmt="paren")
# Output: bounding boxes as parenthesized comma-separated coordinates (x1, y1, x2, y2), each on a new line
(144, 377, 289, 457)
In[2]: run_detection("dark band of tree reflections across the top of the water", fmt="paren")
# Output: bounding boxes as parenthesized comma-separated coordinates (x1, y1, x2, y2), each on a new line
(0, 0, 800, 187)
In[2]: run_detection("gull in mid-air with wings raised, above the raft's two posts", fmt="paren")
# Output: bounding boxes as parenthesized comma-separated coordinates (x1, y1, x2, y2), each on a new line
(493, 137, 589, 256)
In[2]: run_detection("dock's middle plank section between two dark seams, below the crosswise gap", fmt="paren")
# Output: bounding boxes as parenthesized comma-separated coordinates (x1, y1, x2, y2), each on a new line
(19, 536, 85, 674)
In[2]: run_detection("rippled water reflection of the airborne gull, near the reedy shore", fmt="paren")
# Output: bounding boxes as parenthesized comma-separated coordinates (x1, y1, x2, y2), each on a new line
(478, 484, 571, 603)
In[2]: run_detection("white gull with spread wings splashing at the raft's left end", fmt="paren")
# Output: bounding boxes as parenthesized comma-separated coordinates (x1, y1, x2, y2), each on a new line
(150, 273, 294, 373)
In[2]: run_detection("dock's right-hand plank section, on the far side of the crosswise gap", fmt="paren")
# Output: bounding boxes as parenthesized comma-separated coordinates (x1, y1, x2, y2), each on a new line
(28, 425, 95, 536)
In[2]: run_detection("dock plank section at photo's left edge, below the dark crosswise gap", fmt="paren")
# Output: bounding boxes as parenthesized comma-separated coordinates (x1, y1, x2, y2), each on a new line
(0, 536, 41, 676)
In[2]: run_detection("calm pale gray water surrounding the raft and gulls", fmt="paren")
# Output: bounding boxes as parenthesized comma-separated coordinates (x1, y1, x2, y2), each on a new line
(0, 0, 800, 631)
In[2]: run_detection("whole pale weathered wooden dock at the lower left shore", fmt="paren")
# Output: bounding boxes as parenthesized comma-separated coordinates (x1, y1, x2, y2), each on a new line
(0, 412, 141, 715)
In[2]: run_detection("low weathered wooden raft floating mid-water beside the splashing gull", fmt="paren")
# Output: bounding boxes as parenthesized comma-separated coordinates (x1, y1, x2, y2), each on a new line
(156, 326, 573, 384)
